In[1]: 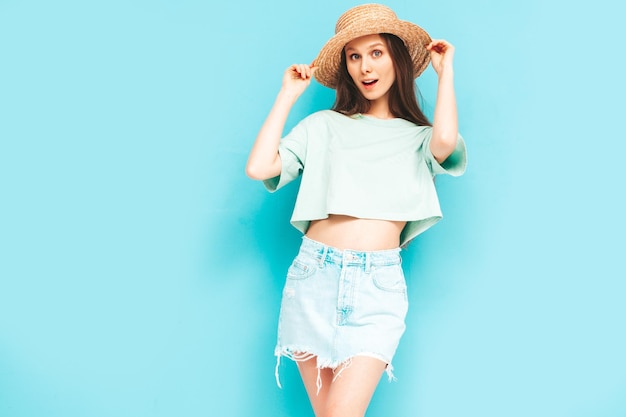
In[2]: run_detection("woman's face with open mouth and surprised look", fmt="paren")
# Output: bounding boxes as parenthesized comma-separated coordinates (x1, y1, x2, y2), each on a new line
(344, 35, 396, 105)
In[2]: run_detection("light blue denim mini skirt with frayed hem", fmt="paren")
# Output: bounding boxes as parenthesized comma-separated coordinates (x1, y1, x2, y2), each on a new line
(275, 236, 408, 388)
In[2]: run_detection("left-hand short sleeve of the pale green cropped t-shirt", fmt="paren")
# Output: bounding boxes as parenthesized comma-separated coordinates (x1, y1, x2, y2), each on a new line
(263, 119, 308, 192)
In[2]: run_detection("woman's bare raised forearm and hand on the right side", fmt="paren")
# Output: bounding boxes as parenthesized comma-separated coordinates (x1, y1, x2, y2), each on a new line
(426, 40, 459, 163)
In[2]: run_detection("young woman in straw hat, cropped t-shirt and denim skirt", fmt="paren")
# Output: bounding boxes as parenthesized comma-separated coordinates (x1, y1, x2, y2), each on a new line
(246, 4, 466, 417)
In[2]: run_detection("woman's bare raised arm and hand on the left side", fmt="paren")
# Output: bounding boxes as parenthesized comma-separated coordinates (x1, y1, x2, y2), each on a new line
(246, 64, 314, 180)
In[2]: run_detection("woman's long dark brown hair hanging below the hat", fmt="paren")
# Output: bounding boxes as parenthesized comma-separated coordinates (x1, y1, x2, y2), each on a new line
(332, 33, 431, 126)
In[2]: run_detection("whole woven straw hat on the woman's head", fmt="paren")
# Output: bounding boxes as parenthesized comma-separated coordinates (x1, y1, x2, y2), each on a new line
(312, 4, 431, 88)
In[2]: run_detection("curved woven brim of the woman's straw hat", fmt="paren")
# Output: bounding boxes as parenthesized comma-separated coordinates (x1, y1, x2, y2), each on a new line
(312, 19, 431, 89)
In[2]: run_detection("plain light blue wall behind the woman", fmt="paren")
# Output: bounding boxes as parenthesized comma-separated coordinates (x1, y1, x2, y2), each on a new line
(0, 0, 626, 417)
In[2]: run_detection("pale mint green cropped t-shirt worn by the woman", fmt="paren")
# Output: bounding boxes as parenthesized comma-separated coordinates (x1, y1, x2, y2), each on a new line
(264, 110, 467, 246)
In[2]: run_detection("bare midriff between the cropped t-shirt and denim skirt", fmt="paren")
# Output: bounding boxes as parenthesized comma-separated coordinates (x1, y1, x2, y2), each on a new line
(306, 214, 406, 251)
